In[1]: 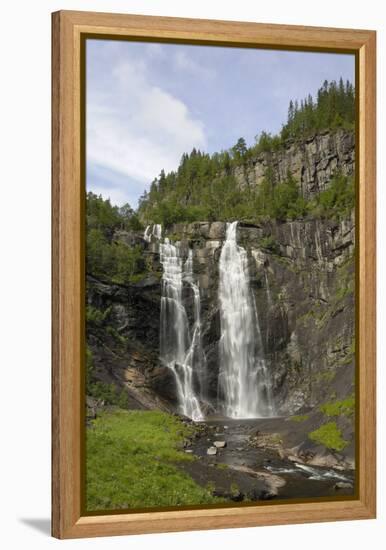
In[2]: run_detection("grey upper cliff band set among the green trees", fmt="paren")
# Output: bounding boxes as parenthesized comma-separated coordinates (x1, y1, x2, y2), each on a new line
(234, 130, 355, 198)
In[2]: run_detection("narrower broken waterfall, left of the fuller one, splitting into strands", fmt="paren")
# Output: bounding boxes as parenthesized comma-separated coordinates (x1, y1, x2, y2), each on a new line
(158, 238, 204, 421)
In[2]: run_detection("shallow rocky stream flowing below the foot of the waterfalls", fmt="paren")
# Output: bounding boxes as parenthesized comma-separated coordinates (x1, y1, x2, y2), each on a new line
(176, 417, 354, 502)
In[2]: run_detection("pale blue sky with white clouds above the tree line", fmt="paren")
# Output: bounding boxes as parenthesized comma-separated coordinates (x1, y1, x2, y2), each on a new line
(86, 39, 355, 208)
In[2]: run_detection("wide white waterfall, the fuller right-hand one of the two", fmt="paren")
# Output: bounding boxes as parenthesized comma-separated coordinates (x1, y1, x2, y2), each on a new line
(219, 222, 274, 418)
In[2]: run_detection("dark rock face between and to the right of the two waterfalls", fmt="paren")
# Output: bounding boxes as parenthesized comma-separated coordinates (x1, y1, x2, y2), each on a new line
(161, 219, 355, 414)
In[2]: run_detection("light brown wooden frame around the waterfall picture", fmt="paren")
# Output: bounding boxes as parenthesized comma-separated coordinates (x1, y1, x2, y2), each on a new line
(52, 11, 376, 538)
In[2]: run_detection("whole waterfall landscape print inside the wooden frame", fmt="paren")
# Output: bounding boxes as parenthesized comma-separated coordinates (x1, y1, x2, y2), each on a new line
(83, 38, 357, 513)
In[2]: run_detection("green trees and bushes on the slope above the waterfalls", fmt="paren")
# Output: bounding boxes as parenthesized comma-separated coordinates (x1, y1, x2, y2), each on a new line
(138, 80, 355, 226)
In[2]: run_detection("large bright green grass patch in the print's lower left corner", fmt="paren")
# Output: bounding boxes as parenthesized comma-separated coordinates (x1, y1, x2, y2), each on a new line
(86, 410, 219, 511)
